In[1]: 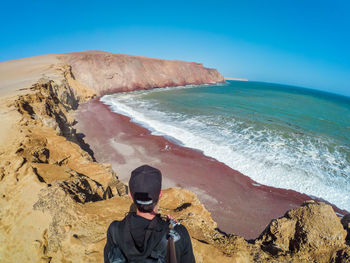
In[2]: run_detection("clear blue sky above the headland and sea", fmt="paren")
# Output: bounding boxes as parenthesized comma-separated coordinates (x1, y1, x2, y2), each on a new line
(0, 0, 350, 96)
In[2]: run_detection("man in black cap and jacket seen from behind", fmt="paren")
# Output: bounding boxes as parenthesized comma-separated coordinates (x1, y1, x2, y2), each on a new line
(104, 165, 195, 263)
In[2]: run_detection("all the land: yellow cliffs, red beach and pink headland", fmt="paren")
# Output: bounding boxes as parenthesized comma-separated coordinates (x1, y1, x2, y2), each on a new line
(0, 51, 350, 262)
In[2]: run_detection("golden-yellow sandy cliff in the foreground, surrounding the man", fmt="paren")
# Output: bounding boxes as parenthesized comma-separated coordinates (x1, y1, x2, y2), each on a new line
(0, 53, 350, 262)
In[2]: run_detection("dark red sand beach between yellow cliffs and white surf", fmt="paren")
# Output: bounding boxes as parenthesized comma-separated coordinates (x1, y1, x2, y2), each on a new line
(76, 99, 344, 239)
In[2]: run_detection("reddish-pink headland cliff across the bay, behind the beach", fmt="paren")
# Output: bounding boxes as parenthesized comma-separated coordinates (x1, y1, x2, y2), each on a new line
(61, 51, 224, 95)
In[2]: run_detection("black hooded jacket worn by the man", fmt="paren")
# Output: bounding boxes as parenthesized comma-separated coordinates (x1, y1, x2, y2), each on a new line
(104, 213, 195, 263)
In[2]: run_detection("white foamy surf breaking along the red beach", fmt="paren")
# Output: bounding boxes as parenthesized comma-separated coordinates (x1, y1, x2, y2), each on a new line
(101, 91, 350, 211)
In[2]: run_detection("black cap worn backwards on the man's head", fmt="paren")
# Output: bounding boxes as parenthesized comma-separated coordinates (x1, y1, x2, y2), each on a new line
(129, 165, 162, 205)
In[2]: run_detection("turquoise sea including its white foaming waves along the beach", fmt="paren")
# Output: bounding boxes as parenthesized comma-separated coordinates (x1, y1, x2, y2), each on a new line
(101, 81, 350, 211)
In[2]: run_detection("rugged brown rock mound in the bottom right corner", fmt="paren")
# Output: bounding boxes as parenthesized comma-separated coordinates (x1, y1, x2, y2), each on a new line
(255, 201, 347, 262)
